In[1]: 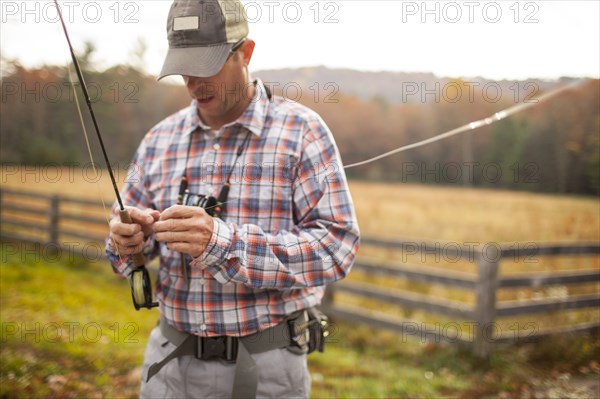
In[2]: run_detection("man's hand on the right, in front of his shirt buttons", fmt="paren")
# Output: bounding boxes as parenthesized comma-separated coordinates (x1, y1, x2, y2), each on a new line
(154, 205, 214, 258)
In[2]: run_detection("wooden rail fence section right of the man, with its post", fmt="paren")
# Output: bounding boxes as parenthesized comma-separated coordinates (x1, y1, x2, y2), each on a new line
(325, 237, 600, 357)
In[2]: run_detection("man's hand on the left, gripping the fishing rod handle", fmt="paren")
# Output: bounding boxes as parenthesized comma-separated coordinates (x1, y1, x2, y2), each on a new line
(110, 207, 160, 255)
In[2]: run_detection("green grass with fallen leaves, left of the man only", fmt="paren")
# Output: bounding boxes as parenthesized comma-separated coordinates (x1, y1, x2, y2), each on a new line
(0, 247, 157, 398)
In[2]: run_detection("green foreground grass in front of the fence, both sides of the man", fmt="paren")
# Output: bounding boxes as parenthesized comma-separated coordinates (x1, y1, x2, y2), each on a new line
(0, 246, 600, 398)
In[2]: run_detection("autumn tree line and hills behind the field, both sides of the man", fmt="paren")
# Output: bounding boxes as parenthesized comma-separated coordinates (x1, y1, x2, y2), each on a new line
(0, 55, 600, 195)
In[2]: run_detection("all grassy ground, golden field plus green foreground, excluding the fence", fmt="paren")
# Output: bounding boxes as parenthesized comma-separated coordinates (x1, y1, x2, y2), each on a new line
(0, 169, 600, 398)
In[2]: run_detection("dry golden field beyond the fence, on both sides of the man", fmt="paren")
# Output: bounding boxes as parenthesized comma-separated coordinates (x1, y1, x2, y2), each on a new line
(1, 166, 600, 243)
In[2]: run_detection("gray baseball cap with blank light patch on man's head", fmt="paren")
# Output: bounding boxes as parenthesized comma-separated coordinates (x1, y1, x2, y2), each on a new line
(158, 0, 248, 80)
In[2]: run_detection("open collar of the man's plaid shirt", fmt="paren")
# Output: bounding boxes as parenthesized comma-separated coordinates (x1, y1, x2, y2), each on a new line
(183, 79, 270, 137)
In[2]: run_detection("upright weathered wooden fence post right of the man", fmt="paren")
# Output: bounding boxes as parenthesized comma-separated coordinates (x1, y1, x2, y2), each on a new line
(473, 249, 501, 358)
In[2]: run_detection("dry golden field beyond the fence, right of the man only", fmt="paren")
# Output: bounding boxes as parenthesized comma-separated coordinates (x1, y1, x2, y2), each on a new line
(351, 182, 600, 242)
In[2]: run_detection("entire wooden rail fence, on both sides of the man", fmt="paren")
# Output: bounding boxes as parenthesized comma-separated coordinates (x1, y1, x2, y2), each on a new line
(0, 189, 600, 357)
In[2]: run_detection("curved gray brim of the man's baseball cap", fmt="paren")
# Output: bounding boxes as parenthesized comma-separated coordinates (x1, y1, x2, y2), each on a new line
(158, 43, 233, 80)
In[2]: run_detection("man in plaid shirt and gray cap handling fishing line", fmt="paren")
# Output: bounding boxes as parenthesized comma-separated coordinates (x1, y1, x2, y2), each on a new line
(107, 0, 359, 398)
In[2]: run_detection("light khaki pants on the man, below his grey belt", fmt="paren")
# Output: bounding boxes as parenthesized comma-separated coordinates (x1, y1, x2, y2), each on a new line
(140, 327, 310, 399)
